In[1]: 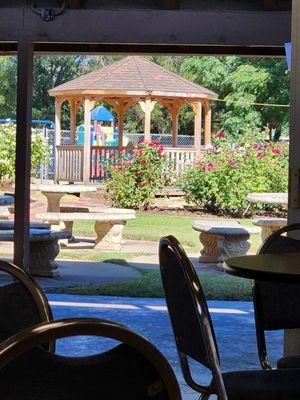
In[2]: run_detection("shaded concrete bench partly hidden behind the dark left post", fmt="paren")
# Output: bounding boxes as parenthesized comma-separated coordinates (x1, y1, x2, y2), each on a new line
(0, 225, 72, 278)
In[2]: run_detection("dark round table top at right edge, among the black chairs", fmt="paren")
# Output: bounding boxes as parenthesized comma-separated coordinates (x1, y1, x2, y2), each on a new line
(224, 253, 300, 284)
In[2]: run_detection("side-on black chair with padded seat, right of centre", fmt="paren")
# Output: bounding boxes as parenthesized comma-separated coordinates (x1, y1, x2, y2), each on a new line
(159, 236, 300, 400)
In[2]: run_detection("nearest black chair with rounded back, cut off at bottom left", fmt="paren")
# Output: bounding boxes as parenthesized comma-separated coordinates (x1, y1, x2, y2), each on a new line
(0, 318, 181, 400)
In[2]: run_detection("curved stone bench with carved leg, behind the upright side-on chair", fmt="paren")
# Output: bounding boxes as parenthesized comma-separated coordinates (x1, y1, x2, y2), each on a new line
(192, 219, 260, 266)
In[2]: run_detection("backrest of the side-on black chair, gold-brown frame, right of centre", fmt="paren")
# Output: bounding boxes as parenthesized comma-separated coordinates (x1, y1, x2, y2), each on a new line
(159, 236, 226, 399)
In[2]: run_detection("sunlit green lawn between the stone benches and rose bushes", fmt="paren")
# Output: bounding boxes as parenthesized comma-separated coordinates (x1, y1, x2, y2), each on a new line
(74, 212, 260, 251)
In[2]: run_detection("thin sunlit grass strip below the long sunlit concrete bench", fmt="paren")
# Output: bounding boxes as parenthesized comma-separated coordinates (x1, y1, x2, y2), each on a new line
(59, 250, 149, 265)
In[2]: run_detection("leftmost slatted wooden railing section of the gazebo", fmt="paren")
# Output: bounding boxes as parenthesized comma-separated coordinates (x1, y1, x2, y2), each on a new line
(54, 145, 84, 182)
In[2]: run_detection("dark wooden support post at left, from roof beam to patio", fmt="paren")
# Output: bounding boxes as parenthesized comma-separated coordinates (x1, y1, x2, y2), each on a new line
(14, 40, 33, 271)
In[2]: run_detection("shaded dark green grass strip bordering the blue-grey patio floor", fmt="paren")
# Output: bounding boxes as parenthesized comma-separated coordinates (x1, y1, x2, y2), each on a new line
(46, 270, 251, 300)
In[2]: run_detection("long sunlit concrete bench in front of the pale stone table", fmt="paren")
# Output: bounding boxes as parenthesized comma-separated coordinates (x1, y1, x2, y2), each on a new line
(36, 209, 135, 251)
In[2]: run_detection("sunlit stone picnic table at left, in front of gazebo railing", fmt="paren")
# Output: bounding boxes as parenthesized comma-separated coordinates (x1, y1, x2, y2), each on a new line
(31, 184, 97, 212)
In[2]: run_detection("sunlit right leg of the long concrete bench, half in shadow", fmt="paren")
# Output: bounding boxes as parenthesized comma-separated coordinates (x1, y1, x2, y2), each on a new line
(94, 221, 126, 251)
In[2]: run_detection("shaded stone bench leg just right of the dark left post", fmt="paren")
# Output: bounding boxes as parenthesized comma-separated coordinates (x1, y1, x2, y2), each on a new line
(29, 239, 60, 278)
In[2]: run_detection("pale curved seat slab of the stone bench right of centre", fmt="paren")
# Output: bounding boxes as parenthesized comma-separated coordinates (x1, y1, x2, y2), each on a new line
(192, 219, 260, 236)
